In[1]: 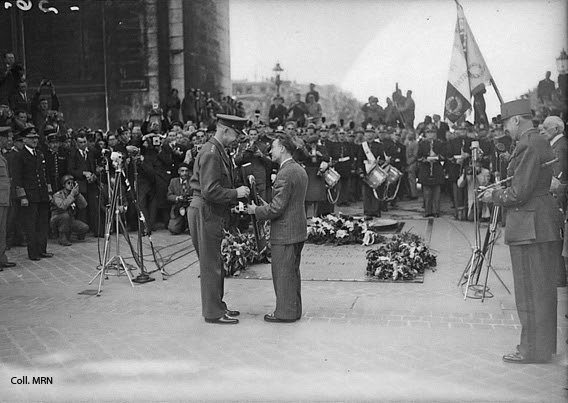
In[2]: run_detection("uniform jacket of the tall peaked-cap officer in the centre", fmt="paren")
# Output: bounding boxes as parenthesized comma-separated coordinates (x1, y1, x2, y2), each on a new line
(189, 137, 237, 217)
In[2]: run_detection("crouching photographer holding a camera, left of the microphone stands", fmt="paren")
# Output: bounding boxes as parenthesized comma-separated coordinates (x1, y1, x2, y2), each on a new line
(50, 175, 89, 246)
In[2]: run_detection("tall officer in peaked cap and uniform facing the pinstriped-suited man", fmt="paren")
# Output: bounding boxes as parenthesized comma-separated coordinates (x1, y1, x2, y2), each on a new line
(189, 114, 250, 324)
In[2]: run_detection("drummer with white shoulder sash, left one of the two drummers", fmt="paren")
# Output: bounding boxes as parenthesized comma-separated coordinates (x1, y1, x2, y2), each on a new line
(357, 124, 390, 218)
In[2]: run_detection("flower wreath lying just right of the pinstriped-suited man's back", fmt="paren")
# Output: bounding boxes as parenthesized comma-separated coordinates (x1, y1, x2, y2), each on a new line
(306, 214, 385, 245)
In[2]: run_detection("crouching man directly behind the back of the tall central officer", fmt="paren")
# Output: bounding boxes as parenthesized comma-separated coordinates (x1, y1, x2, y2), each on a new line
(168, 163, 193, 235)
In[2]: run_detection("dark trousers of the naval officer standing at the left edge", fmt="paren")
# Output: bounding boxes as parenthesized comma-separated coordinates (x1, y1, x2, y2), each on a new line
(20, 202, 49, 258)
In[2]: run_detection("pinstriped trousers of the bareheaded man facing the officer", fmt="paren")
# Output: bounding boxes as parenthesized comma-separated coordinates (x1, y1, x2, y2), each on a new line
(271, 242, 304, 319)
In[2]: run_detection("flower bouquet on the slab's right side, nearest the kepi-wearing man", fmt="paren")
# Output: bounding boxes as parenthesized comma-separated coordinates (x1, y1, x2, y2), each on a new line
(367, 232, 436, 281)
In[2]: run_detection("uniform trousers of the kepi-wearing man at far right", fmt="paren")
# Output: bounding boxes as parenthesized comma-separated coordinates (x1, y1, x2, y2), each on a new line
(509, 241, 562, 361)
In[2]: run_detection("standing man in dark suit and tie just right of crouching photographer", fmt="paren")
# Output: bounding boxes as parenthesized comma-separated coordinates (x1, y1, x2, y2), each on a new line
(66, 132, 100, 237)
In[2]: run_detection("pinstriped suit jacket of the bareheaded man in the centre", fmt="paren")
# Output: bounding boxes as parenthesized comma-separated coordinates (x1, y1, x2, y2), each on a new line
(255, 159, 308, 245)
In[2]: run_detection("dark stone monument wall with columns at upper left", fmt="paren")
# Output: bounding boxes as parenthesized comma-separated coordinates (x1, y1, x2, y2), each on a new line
(0, 0, 231, 129)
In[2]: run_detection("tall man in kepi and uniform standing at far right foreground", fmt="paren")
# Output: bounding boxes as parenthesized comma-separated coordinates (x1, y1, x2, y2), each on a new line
(480, 99, 562, 364)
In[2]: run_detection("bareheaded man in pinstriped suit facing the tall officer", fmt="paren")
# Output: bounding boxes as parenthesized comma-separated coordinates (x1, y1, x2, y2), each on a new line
(247, 133, 308, 322)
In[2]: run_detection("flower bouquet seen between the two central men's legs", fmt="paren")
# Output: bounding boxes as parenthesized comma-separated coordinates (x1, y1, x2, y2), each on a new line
(221, 229, 270, 276)
